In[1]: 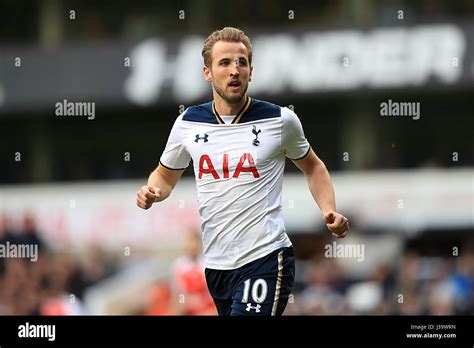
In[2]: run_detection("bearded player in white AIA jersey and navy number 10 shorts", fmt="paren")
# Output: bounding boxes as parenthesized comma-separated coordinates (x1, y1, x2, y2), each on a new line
(137, 27, 349, 315)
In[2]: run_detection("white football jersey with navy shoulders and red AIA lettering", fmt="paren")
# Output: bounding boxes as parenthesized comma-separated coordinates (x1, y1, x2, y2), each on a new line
(160, 97, 310, 270)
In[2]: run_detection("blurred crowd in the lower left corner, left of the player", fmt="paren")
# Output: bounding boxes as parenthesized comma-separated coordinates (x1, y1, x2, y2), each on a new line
(0, 215, 114, 315)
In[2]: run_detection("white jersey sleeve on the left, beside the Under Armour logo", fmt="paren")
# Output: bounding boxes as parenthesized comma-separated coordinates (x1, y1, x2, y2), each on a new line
(160, 111, 191, 170)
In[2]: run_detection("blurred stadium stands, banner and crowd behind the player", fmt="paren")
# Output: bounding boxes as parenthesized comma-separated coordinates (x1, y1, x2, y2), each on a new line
(0, 0, 474, 315)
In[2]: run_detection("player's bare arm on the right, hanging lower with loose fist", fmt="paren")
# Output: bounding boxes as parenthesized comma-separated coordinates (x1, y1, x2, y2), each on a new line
(293, 149, 349, 238)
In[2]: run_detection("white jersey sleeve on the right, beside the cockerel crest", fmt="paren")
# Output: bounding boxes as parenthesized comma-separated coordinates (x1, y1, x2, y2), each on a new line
(281, 107, 311, 160)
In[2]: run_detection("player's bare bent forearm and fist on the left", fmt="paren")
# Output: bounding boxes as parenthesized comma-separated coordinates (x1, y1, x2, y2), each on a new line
(137, 164, 184, 209)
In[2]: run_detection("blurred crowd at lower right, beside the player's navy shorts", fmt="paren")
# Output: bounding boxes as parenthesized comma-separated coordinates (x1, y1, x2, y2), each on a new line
(286, 247, 474, 315)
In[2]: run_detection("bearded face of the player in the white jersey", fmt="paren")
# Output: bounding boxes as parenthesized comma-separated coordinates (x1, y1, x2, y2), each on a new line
(204, 41, 252, 104)
